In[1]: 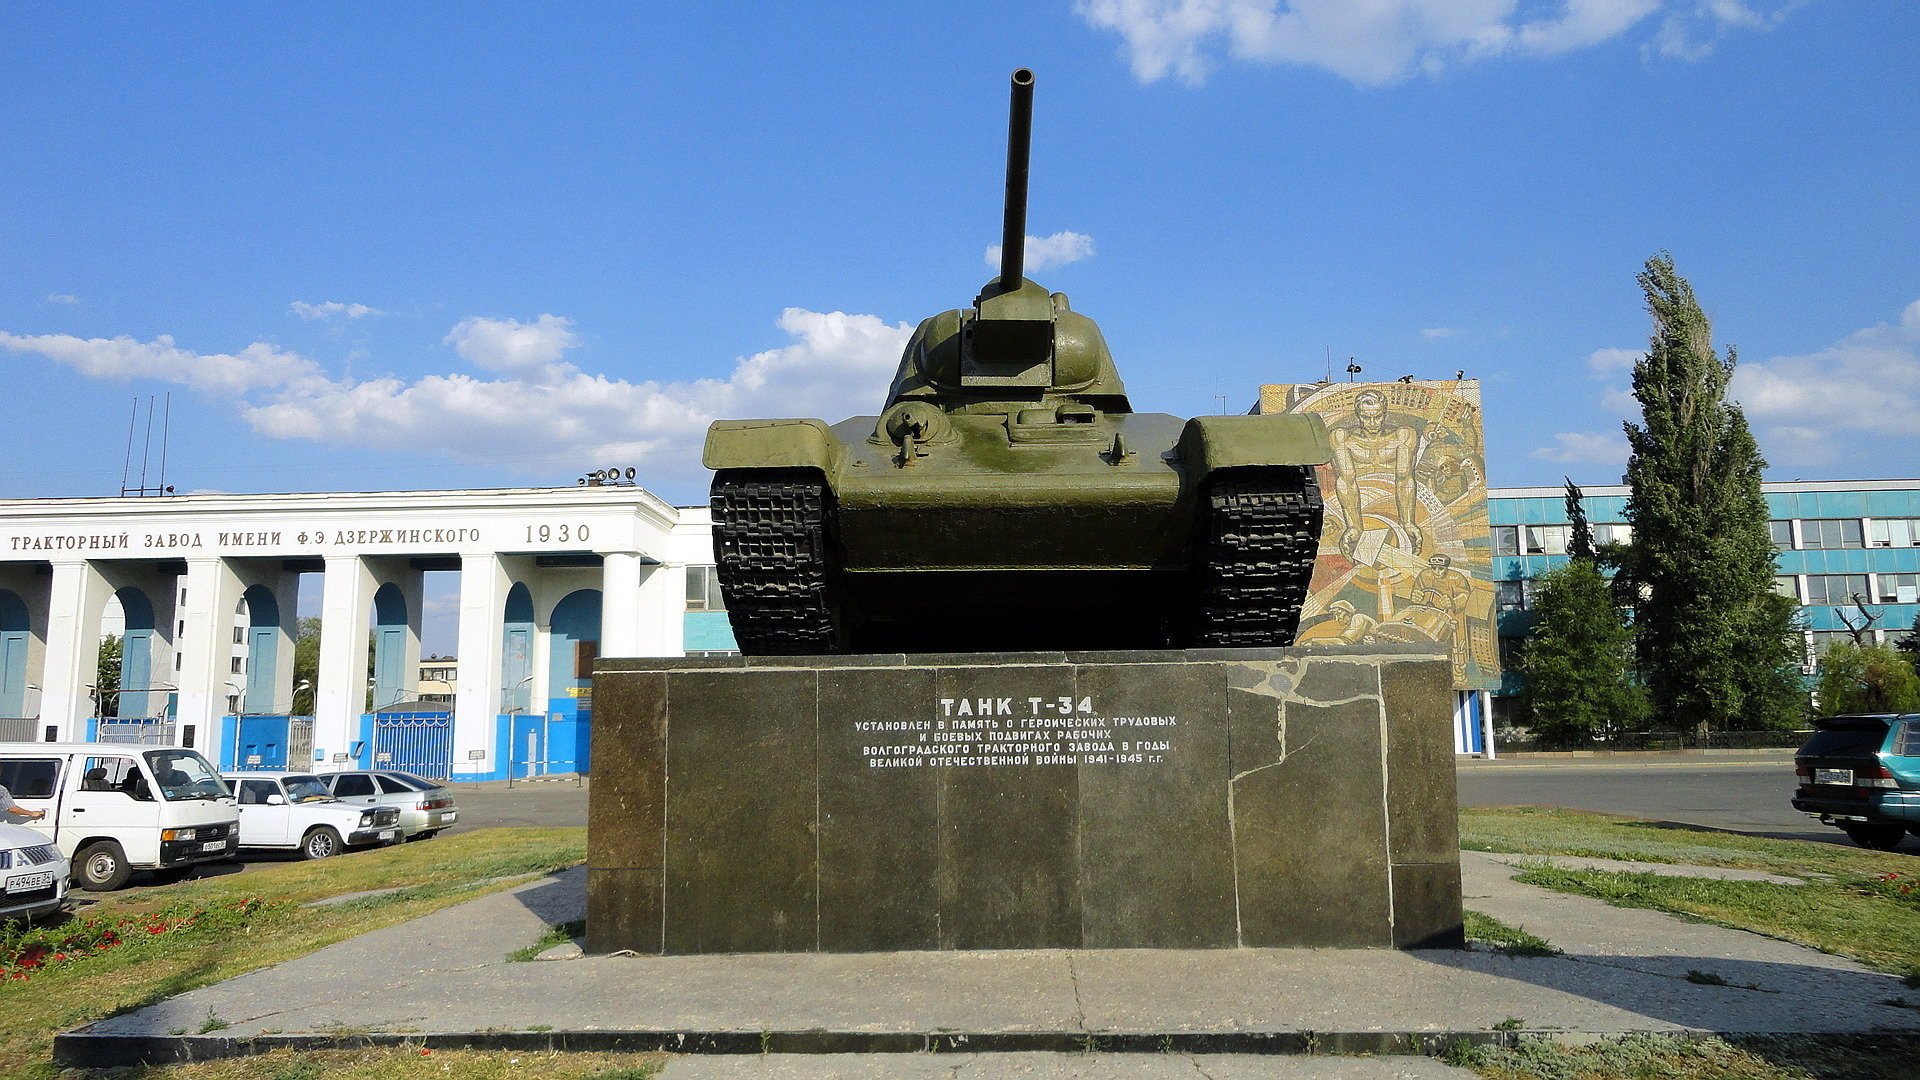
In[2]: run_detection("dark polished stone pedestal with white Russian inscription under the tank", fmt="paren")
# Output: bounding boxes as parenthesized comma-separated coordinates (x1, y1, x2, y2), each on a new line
(588, 646, 1461, 953)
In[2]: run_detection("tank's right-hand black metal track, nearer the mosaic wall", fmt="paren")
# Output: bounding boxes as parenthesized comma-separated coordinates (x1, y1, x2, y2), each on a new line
(1194, 465, 1325, 648)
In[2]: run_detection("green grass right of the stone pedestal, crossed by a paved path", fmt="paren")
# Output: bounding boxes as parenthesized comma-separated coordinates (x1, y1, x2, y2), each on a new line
(1459, 807, 1920, 980)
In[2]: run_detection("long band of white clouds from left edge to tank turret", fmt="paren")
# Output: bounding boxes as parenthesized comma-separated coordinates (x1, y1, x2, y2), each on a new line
(0, 307, 912, 469)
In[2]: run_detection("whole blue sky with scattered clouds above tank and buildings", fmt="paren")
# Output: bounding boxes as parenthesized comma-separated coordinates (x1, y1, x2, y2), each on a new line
(0, 0, 1920, 502)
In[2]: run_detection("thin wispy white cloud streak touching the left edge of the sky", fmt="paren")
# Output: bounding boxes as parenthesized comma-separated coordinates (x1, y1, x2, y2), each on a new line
(0, 331, 319, 396)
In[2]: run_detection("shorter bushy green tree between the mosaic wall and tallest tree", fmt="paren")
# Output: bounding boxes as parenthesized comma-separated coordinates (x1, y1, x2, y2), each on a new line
(1519, 557, 1647, 746)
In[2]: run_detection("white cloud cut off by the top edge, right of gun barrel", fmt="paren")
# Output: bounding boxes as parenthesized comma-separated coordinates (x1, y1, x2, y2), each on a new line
(1075, 0, 1803, 86)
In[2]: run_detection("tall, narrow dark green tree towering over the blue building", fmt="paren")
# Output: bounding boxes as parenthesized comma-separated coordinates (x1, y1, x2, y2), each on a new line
(1622, 254, 1805, 730)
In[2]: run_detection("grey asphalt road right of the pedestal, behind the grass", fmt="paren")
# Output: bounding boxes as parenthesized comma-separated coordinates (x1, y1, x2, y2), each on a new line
(1459, 757, 1920, 855)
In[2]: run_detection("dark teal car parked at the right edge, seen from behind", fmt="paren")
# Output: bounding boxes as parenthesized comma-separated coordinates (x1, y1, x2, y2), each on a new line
(1793, 713, 1920, 851)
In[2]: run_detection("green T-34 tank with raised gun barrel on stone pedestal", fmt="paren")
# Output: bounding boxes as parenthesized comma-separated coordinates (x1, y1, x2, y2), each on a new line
(705, 69, 1331, 655)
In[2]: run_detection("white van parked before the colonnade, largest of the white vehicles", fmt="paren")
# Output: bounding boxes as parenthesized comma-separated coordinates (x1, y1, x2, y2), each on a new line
(0, 742, 240, 892)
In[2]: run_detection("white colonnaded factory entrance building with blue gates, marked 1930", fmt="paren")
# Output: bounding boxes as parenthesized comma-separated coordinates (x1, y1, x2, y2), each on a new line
(0, 486, 732, 778)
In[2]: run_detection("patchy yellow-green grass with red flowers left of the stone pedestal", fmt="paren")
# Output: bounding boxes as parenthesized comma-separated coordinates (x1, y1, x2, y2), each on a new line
(0, 828, 583, 1078)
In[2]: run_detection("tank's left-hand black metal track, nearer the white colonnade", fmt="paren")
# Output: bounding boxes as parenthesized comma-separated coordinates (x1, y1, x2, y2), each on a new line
(710, 469, 837, 655)
